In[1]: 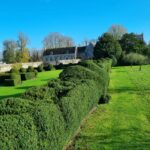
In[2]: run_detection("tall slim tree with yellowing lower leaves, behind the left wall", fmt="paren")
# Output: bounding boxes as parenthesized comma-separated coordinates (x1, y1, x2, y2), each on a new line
(16, 33, 30, 62)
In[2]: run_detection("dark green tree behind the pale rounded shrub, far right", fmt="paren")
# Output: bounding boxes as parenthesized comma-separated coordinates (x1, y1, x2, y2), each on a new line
(120, 33, 146, 54)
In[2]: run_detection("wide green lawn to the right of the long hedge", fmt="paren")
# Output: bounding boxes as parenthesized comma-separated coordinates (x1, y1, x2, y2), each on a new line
(74, 66, 150, 150)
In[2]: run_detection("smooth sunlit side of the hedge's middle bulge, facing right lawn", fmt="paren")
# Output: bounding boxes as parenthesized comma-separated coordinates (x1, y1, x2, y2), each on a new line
(60, 80, 102, 131)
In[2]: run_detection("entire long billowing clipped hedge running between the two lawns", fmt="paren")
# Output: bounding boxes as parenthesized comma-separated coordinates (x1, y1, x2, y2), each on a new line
(0, 60, 111, 150)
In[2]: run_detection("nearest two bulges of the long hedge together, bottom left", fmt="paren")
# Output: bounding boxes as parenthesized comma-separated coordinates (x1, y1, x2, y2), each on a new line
(0, 98, 66, 150)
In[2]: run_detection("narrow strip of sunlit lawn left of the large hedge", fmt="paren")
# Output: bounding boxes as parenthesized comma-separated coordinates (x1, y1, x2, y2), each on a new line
(0, 70, 61, 99)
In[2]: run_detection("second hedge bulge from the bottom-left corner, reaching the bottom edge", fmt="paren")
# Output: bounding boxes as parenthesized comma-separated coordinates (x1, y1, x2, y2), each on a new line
(32, 101, 66, 150)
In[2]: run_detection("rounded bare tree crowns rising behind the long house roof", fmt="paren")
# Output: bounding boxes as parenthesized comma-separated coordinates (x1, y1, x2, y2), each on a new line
(43, 32, 74, 49)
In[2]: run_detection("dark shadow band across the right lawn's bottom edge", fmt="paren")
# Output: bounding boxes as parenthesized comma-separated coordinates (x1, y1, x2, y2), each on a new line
(74, 128, 150, 150)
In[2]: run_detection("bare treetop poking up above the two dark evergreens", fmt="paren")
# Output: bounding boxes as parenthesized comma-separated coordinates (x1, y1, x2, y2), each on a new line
(108, 25, 127, 40)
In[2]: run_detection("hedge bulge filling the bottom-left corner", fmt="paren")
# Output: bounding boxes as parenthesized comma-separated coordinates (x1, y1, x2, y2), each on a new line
(0, 98, 38, 150)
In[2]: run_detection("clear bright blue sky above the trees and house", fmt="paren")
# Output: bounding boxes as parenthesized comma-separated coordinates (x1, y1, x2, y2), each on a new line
(0, 0, 150, 49)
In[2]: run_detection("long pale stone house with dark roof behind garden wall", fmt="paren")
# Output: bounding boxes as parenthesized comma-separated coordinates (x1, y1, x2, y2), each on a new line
(43, 43, 94, 65)
